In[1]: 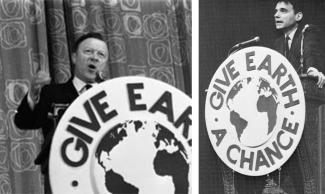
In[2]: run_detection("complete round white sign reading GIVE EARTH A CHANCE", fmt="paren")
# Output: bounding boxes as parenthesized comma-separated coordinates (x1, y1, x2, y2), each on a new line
(205, 47, 305, 176)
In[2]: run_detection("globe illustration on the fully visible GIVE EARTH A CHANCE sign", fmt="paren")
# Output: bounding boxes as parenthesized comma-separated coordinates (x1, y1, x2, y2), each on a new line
(226, 77, 279, 147)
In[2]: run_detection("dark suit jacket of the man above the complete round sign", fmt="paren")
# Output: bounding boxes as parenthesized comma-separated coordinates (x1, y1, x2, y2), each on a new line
(273, 23, 325, 73)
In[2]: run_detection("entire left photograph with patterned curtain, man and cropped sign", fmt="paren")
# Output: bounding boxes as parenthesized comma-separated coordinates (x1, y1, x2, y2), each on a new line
(0, 0, 191, 194)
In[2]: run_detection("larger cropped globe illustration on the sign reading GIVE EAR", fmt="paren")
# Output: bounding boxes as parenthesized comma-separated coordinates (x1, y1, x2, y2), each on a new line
(95, 120, 190, 194)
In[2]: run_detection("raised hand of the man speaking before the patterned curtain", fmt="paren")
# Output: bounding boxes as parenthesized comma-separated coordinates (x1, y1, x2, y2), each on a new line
(29, 71, 51, 103)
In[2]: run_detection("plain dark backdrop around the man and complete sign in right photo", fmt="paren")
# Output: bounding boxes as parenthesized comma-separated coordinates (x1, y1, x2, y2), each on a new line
(199, 0, 325, 194)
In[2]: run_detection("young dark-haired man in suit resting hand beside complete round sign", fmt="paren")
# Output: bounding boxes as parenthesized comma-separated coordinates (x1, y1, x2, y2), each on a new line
(274, 0, 325, 88)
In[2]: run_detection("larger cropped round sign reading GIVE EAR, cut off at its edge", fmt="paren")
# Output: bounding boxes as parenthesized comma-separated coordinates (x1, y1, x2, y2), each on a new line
(49, 77, 192, 194)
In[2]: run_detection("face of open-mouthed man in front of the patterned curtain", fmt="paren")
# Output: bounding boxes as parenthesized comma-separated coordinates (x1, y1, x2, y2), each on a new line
(72, 38, 108, 83)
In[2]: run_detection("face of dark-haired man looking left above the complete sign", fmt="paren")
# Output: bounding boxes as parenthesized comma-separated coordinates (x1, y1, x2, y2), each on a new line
(274, 2, 302, 32)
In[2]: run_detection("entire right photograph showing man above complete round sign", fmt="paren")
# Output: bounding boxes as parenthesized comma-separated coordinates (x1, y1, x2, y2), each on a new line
(199, 0, 325, 194)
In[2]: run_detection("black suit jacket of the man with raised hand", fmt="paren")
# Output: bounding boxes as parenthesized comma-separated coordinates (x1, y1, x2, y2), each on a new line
(15, 79, 78, 173)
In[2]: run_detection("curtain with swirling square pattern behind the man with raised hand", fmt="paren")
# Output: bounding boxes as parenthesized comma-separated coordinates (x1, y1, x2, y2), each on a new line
(0, 0, 191, 194)
